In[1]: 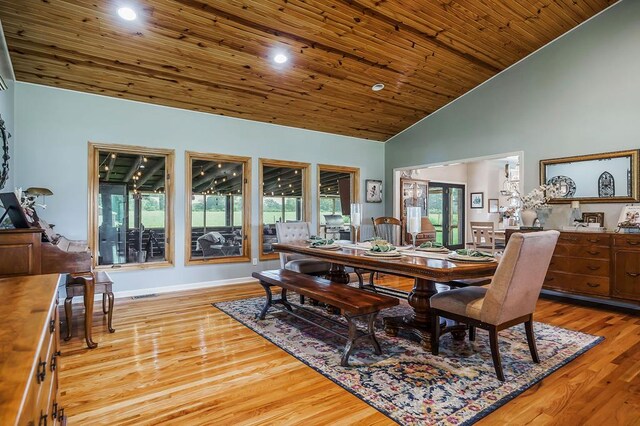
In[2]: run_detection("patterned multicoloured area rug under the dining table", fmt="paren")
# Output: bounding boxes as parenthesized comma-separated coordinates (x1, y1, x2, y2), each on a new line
(214, 294, 603, 425)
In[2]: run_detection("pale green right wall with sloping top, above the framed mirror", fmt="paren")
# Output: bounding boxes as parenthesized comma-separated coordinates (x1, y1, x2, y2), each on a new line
(385, 0, 640, 223)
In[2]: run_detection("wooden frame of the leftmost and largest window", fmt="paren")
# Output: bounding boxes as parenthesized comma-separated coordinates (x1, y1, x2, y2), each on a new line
(87, 142, 175, 270)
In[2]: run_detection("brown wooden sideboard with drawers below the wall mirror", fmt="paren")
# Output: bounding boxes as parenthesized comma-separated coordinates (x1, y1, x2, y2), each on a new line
(506, 229, 640, 307)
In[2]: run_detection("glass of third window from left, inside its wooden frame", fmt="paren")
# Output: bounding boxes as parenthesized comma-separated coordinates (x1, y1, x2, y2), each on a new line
(261, 162, 307, 255)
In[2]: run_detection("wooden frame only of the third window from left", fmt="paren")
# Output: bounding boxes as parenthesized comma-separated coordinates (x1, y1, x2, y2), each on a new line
(258, 158, 311, 261)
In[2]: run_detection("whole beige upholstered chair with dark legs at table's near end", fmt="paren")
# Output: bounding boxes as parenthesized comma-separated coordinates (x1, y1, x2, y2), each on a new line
(430, 231, 560, 381)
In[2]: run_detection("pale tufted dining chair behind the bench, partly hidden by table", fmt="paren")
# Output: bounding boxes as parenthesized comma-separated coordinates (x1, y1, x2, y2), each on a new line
(276, 222, 331, 303)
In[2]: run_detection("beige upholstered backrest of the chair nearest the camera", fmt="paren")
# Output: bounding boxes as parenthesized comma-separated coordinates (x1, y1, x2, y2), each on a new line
(480, 231, 560, 325)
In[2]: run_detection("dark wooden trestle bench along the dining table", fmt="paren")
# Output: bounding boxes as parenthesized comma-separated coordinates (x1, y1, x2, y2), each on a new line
(252, 269, 399, 367)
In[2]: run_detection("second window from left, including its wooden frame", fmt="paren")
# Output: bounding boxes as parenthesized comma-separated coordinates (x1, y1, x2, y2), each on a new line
(185, 152, 251, 265)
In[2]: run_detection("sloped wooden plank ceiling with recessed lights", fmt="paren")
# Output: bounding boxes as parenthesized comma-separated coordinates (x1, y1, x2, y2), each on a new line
(0, 0, 616, 143)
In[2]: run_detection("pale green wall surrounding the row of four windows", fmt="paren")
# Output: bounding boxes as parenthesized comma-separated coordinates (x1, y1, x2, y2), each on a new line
(16, 83, 384, 291)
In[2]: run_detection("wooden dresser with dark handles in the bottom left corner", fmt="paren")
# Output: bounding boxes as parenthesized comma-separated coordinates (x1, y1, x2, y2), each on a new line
(0, 274, 66, 426)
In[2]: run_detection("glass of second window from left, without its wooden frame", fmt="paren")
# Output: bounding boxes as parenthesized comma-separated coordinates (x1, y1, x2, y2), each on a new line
(190, 158, 245, 260)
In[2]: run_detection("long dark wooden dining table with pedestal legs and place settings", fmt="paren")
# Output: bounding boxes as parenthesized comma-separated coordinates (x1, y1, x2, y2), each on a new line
(273, 241, 498, 347)
